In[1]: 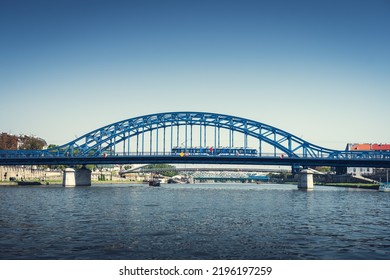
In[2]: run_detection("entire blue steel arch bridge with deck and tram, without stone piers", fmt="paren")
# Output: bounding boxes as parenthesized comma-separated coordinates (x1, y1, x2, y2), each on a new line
(0, 112, 390, 168)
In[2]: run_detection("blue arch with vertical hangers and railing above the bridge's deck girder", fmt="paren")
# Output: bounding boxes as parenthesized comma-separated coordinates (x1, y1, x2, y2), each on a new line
(0, 112, 390, 164)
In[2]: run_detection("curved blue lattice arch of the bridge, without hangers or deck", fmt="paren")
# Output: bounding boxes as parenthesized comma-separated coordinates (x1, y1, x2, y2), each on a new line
(46, 112, 341, 158)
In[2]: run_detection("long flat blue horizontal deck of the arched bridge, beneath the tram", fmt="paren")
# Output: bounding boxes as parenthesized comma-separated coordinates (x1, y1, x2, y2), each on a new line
(0, 155, 390, 168)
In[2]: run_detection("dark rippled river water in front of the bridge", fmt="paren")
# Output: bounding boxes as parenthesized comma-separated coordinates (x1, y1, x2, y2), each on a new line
(0, 184, 390, 260)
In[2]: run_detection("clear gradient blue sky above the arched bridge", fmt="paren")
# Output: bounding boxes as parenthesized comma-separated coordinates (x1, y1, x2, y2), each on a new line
(0, 0, 390, 149)
